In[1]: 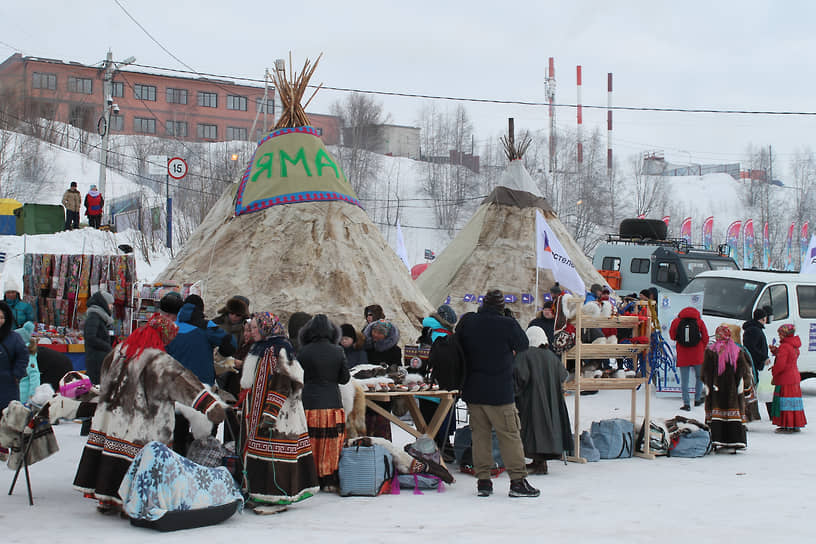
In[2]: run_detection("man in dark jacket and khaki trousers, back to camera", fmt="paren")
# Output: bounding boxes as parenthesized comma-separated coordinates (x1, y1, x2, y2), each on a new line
(456, 289, 540, 497)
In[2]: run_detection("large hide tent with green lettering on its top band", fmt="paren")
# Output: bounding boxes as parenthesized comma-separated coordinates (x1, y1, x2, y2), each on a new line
(159, 56, 432, 336)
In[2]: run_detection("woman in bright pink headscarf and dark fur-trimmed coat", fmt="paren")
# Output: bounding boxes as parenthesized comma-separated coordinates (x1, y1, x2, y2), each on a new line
(702, 324, 751, 453)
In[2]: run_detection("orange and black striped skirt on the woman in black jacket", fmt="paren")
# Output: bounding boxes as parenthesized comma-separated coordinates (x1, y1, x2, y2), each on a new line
(306, 408, 346, 487)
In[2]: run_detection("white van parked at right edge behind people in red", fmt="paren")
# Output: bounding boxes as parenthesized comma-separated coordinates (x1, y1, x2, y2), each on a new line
(683, 270, 816, 379)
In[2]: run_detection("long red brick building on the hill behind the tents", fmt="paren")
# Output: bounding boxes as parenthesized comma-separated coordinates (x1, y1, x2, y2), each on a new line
(0, 53, 339, 145)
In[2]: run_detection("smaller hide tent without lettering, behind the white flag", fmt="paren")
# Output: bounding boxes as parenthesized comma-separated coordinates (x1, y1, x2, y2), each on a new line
(416, 160, 607, 324)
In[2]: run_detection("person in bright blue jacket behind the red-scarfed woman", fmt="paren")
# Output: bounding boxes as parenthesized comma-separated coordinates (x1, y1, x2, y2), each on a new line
(166, 295, 237, 455)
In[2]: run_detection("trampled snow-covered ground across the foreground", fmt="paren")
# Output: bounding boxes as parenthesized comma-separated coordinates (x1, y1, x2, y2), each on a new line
(0, 380, 816, 544)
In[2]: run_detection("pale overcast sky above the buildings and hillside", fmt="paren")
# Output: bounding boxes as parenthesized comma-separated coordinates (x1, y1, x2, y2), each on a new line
(0, 0, 816, 177)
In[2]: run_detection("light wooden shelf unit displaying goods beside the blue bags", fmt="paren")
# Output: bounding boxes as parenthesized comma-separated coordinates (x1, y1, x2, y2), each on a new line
(561, 302, 655, 463)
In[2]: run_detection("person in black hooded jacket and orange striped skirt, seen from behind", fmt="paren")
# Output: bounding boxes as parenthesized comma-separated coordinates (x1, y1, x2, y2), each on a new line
(298, 314, 351, 493)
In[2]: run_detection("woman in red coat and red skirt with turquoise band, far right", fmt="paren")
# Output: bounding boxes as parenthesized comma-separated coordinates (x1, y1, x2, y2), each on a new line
(771, 323, 807, 433)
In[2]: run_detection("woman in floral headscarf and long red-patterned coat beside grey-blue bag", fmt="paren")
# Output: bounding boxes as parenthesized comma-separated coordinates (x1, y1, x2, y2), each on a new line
(241, 312, 319, 507)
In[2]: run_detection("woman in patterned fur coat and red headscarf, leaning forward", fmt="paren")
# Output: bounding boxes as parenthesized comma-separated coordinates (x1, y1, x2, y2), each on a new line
(74, 314, 224, 513)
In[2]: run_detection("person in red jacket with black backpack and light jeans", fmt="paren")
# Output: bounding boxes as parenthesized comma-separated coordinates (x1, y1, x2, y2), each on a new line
(669, 307, 708, 412)
